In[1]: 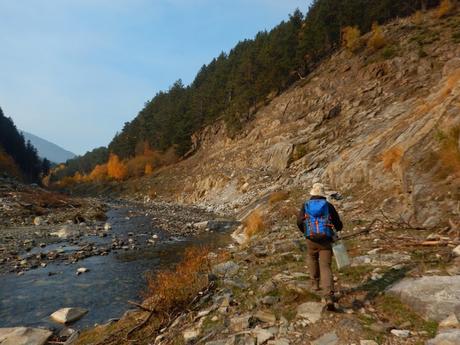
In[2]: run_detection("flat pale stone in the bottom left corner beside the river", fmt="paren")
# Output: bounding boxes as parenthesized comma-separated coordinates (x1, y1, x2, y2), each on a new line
(0, 327, 53, 345)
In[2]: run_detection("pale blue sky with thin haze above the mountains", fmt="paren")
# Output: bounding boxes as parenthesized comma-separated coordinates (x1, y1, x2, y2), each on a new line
(0, 0, 310, 154)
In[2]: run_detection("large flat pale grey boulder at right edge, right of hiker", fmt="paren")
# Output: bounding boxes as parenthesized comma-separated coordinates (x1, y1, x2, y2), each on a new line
(388, 275, 460, 322)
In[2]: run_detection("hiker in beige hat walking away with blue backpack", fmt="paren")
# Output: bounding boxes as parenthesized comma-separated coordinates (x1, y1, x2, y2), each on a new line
(297, 183, 343, 310)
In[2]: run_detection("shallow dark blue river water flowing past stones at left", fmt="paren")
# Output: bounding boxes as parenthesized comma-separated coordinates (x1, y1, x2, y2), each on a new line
(0, 208, 235, 328)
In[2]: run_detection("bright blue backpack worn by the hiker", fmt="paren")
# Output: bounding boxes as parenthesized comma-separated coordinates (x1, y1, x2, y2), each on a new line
(304, 199, 334, 239)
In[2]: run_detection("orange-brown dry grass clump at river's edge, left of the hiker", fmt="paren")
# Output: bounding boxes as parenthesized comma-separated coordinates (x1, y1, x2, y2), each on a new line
(144, 247, 211, 314)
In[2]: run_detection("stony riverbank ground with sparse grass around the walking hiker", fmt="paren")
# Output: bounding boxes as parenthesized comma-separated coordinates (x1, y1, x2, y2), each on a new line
(72, 188, 460, 345)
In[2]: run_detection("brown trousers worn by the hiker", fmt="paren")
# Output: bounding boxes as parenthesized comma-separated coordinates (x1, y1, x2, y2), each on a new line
(307, 239, 334, 296)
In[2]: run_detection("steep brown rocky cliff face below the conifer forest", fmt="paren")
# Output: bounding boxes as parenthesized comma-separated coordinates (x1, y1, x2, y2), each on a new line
(143, 15, 460, 227)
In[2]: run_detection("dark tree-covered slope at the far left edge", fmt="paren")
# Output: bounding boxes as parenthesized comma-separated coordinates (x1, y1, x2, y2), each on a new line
(0, 108, 50, 182)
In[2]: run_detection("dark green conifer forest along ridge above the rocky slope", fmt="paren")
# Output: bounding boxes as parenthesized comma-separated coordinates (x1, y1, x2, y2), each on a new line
(109, 0, 439, 158)
